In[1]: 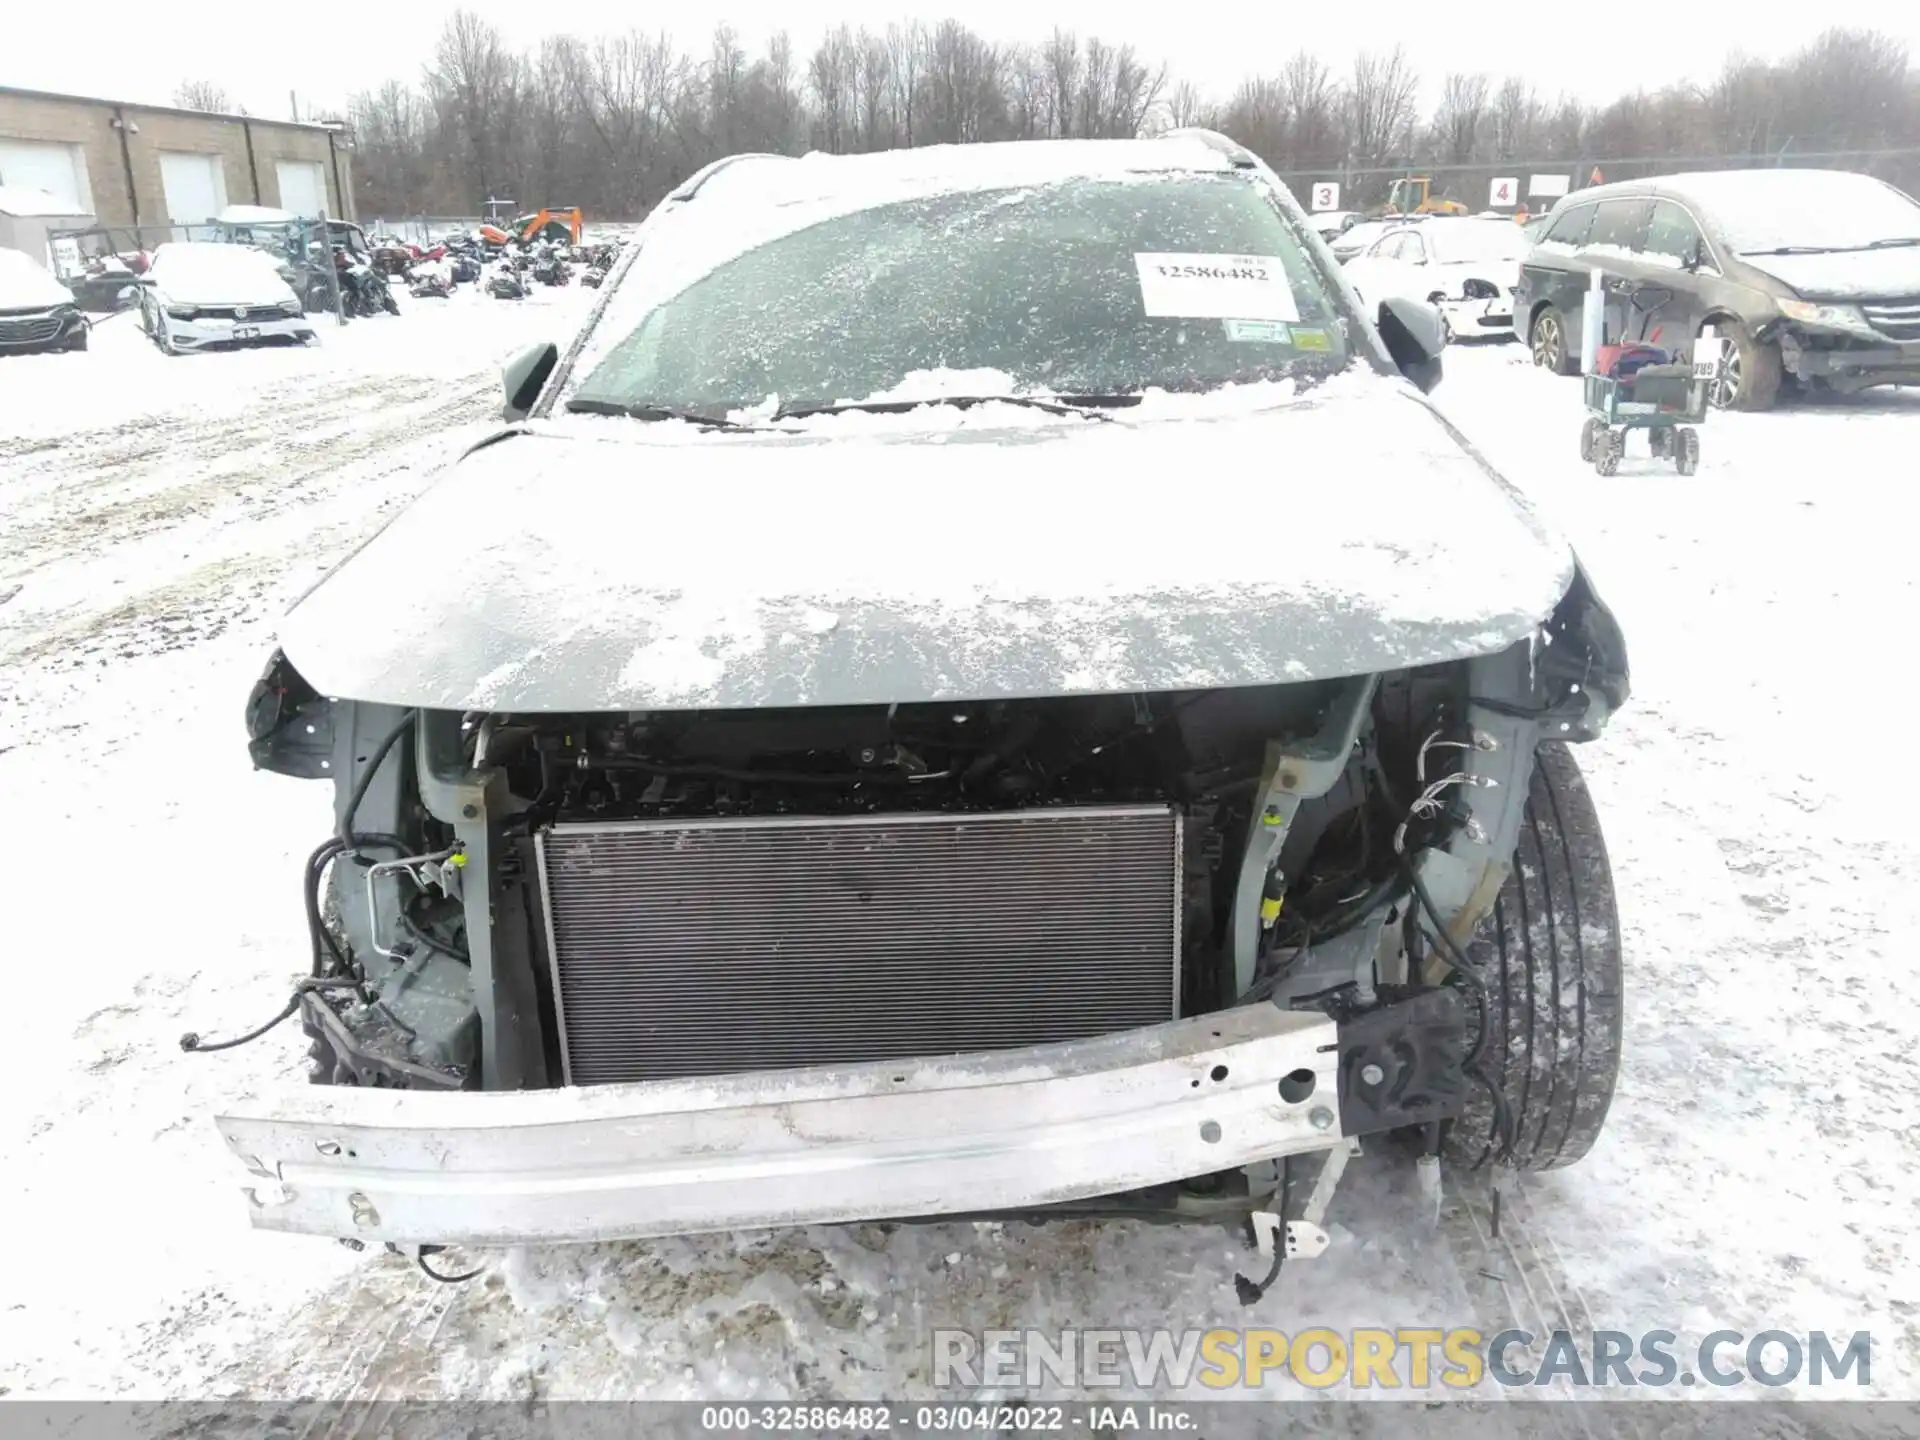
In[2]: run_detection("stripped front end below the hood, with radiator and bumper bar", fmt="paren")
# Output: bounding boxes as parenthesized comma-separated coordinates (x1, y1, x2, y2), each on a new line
(219, 570, 1628, 1244)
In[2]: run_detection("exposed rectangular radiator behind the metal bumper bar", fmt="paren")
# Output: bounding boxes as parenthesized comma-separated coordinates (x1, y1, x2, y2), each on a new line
(538, 806, 1181, 1085)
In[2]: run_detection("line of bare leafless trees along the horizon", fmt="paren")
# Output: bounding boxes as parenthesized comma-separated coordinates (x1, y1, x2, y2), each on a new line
(176, 12, 1920, 219)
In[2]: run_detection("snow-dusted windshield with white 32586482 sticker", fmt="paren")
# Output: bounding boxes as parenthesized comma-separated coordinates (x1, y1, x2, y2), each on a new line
(568, 175, 1352, 417)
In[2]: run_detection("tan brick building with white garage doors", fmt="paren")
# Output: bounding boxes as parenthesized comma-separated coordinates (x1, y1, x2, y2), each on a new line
(0, 84, 353, 225)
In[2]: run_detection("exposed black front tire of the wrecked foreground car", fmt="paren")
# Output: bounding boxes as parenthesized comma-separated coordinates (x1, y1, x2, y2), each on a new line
(1442, 741, 1624, 1169)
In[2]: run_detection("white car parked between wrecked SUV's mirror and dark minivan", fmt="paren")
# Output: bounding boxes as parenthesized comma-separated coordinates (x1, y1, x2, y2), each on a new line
(1344, 215, 1528, 336)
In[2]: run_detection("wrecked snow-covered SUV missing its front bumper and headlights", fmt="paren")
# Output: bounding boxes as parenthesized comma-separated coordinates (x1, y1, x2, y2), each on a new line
(217, 132, 1628, 1267)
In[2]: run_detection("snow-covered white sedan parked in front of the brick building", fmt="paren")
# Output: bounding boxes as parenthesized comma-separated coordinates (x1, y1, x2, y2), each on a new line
(140, 240, 319, 355)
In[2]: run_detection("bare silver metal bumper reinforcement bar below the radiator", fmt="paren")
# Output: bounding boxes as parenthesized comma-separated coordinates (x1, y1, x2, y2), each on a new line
(219, 1004, 1344, 1244)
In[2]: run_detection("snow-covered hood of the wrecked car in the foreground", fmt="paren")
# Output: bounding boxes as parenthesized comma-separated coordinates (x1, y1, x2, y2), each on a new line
(282, 376, 1574, 710)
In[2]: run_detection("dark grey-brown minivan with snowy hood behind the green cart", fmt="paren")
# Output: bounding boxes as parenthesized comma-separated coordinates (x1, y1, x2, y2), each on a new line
(1515, 169, 1920, 411)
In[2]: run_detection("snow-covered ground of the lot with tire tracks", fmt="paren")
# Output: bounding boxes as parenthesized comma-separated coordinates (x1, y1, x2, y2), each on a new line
(0, 314, 1920, 1398)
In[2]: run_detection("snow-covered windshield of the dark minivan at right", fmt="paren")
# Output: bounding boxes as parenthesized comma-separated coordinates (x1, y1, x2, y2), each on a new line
(1684, 171, 1920, 255)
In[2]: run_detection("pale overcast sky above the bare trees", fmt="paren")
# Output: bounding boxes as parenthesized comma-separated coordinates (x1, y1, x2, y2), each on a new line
(0, 0, 1920, 119)
